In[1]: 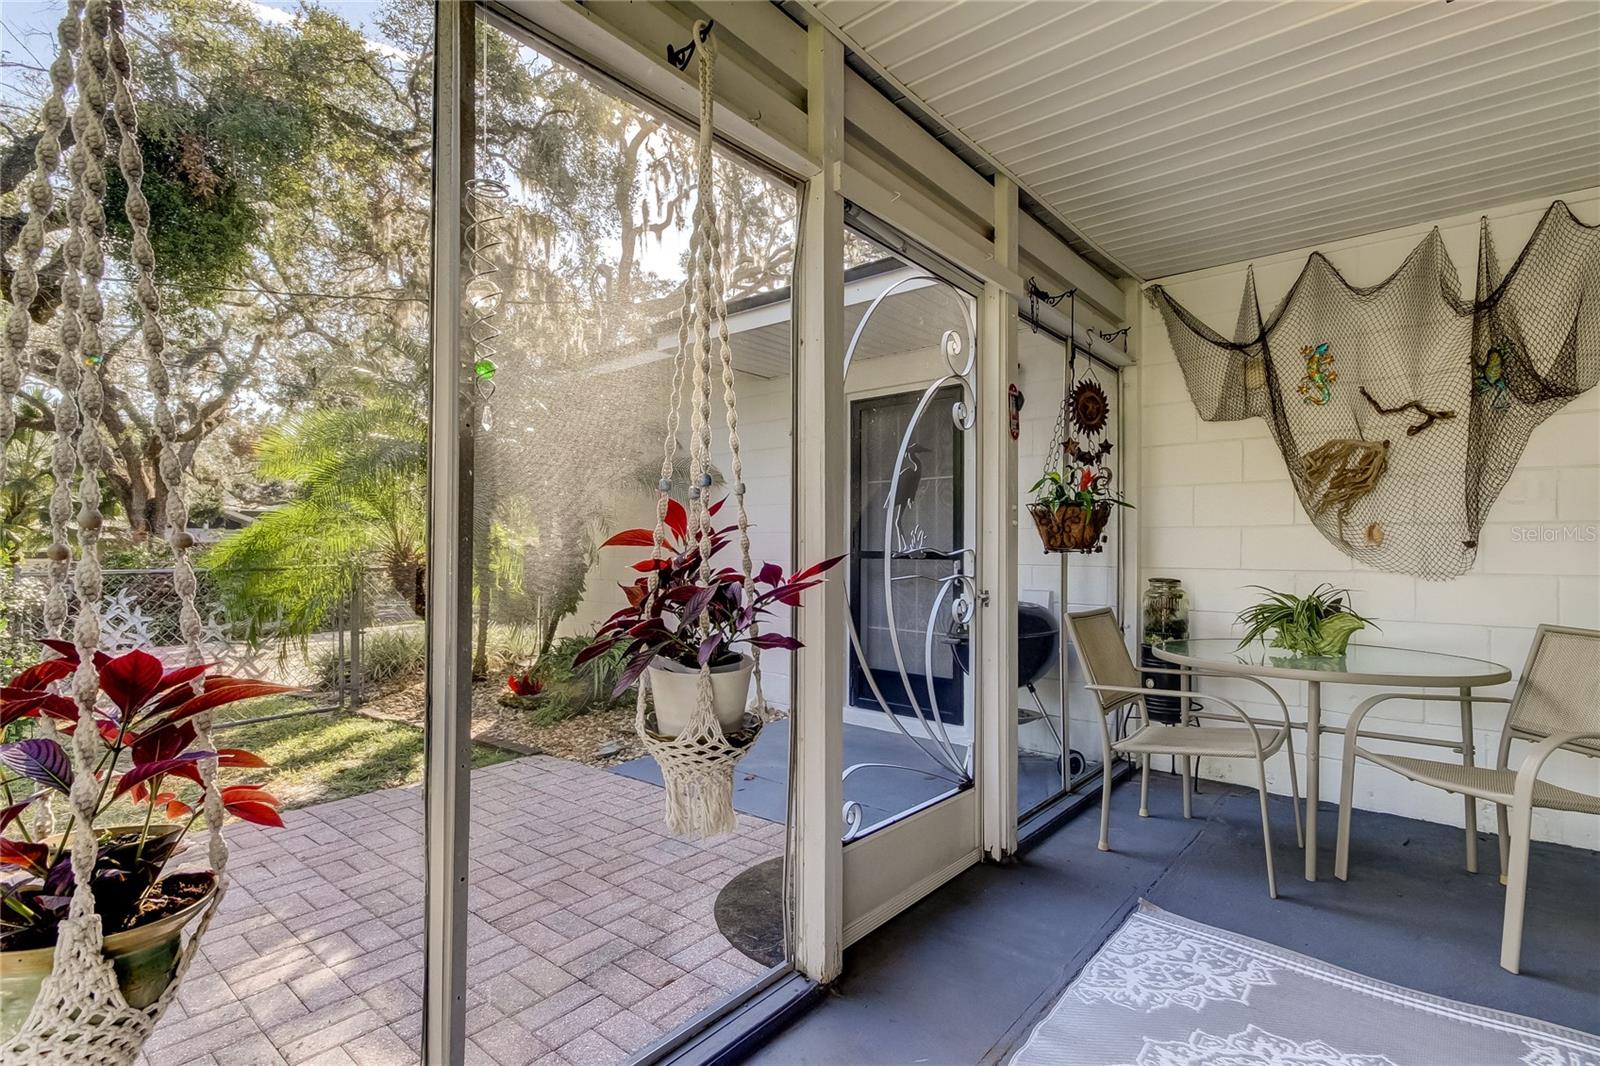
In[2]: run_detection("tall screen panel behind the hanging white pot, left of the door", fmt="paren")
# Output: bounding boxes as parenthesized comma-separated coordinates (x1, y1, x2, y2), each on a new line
(461, 20, 797, 1063)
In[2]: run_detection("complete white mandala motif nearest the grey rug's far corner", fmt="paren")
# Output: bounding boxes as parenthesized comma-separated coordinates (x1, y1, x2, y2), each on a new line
(1072, 920, 1277, 1013)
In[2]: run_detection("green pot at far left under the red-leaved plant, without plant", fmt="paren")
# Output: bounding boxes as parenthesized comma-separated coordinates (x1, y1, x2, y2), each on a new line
(0, 884, 216, 1040)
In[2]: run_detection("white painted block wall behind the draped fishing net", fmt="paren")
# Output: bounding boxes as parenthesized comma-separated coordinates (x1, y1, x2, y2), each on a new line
(1138, 189, 1600, 845)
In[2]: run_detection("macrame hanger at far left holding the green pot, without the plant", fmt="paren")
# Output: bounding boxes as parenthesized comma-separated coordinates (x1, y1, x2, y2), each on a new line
(0, 0, 227, 1066)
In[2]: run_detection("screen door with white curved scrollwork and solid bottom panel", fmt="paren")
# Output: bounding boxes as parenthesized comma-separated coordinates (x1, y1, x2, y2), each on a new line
(843, 219, 978, 943)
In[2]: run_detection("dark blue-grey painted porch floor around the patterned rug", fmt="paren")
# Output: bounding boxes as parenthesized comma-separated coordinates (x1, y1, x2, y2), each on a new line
(750, 773, 1600, 1066)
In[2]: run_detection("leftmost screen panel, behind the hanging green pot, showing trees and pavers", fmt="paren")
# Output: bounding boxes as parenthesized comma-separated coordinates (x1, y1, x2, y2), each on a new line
(0, 2, 438, 1063)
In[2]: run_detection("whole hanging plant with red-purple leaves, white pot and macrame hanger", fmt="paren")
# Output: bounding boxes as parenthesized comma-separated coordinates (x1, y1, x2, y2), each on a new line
(574, 22, 842, 837)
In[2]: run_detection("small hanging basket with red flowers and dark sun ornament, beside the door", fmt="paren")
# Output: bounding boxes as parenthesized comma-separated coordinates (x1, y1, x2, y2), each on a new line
(1027, 290, 1133, 554)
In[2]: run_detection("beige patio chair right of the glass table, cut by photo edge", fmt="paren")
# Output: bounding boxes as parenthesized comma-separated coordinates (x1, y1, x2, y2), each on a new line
(1334, 626, 1600, 973)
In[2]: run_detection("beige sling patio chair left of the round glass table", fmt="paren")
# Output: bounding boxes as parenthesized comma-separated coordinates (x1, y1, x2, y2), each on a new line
(1067, 607, 1304, 900)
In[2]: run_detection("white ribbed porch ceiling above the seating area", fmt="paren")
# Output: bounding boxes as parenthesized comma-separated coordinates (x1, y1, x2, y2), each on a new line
(810, 0, 1600, 279)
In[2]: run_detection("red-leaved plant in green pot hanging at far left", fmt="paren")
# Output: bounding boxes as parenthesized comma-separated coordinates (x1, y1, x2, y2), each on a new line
(0, 640, 294, 1039)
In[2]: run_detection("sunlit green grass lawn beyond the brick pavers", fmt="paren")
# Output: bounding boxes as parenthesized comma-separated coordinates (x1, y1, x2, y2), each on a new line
(216, 707, 517, 810)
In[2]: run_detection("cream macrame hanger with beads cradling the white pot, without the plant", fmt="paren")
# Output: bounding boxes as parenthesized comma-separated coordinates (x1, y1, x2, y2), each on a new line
(634, 21, 770, 837)
